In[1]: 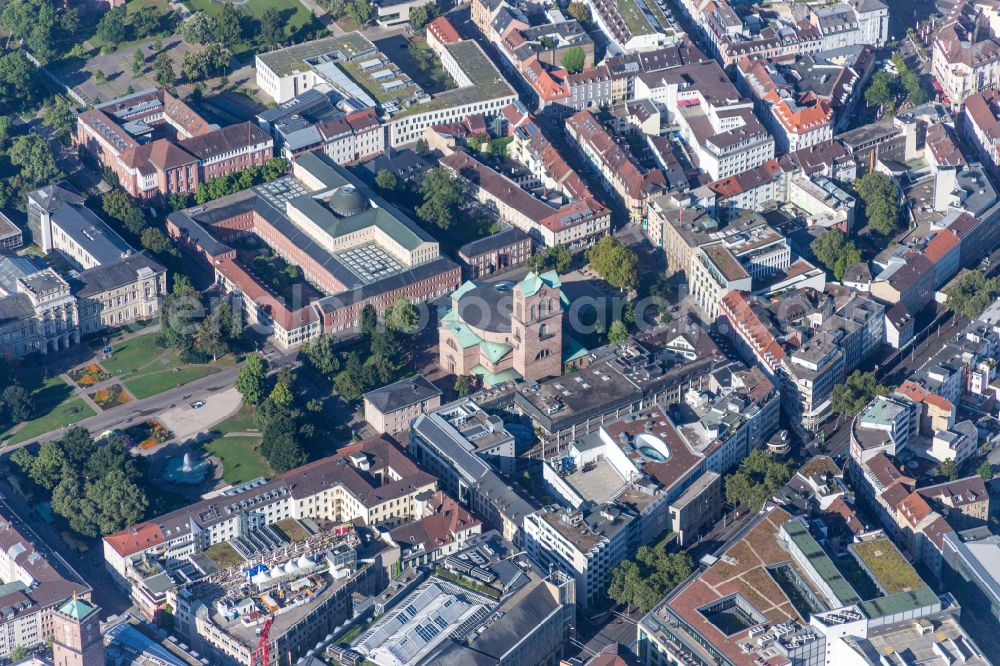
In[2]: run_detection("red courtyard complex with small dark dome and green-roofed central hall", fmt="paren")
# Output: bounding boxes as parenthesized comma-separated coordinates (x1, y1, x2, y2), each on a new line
(167, 153, 461, 348)
